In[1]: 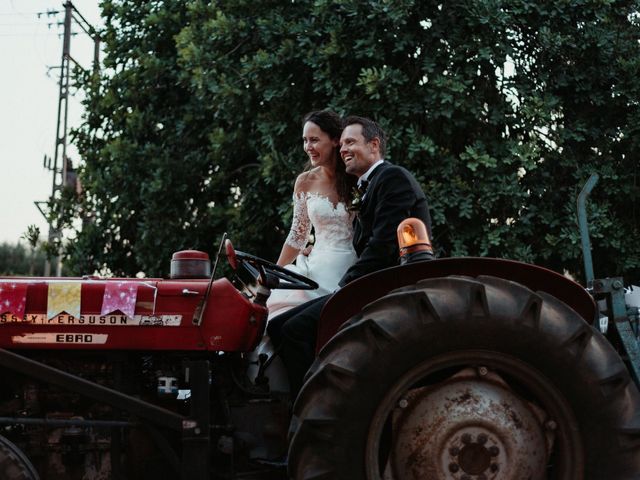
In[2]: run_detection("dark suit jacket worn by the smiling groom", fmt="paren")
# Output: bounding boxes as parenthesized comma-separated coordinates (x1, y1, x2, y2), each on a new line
(340, 161, 431, 287)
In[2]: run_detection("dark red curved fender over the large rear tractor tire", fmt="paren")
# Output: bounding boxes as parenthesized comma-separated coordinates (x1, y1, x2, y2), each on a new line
(316, 257, 596, 351)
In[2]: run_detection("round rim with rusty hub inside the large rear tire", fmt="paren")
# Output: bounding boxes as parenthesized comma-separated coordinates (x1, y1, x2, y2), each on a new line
(365, 350, 583, 480)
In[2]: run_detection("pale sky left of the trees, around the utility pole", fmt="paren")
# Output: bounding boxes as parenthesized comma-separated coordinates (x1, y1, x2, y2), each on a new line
(0, 0, 102, 243)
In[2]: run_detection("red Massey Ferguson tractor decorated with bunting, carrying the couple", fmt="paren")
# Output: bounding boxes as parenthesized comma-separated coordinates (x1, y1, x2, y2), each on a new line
(0, 197, 640, 480)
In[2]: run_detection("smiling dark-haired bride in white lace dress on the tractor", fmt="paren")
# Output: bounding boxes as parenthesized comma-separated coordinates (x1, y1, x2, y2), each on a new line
(267, 110, 357, 318)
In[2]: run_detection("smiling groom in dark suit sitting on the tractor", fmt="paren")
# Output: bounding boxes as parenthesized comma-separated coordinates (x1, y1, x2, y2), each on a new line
(268, 116, 431, 397)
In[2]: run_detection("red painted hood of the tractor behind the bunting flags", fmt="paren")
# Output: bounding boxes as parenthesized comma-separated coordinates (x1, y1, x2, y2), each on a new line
(0, 278, 266, 351)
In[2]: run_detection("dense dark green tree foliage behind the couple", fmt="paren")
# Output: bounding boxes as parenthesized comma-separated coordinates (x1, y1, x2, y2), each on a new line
(59, 0, 640, 284)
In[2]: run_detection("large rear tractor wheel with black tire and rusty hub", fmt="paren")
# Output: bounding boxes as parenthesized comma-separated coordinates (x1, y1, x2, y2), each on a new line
(289, 276, 640, 480)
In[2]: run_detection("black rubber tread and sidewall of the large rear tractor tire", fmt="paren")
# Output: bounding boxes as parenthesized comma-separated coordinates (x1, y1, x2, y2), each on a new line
(289, 276, 640, 480)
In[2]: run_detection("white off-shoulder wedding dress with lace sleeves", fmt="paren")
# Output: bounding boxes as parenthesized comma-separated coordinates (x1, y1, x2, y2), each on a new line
(267, 192, 357, 318)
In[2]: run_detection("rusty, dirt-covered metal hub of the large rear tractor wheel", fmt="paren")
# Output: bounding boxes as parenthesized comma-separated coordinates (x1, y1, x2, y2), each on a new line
(390, 369, 549, 480)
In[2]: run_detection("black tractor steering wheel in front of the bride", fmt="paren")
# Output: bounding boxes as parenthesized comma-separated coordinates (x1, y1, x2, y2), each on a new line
(225, 239, 318, 290)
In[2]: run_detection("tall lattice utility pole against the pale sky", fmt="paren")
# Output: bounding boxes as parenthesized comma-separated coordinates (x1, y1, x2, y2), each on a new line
(35, 1, 100, 277)
